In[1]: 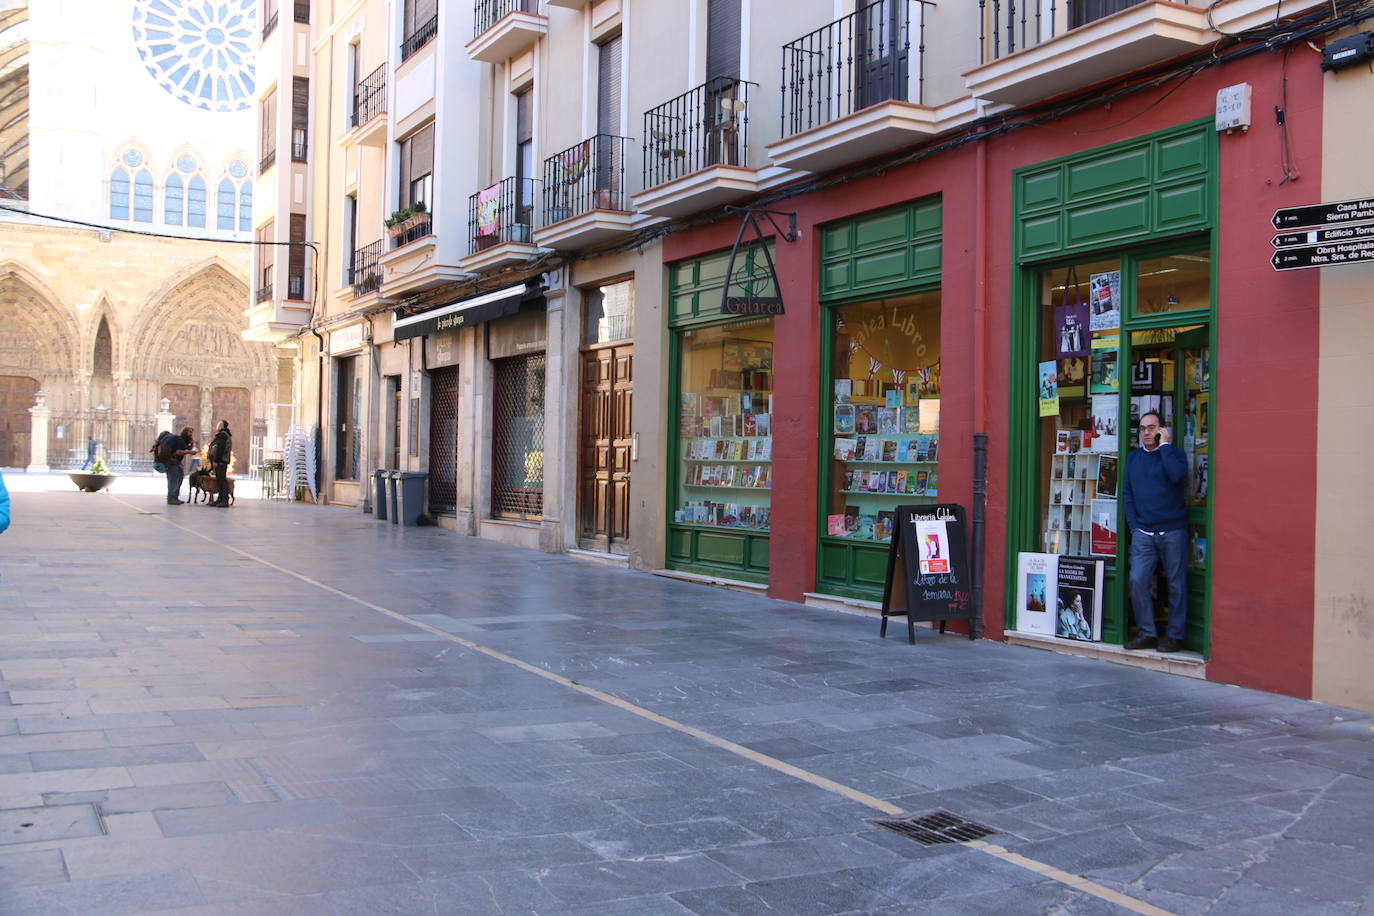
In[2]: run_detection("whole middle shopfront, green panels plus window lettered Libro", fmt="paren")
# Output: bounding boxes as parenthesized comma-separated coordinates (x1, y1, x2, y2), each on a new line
(816, 199, 943, 600)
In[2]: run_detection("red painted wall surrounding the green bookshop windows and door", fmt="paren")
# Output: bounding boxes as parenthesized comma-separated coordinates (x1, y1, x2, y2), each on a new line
(664, 48, 1322, 696)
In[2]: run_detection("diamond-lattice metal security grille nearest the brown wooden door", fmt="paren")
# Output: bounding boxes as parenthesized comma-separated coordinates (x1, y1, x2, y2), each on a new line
(492, 353, 544, 518)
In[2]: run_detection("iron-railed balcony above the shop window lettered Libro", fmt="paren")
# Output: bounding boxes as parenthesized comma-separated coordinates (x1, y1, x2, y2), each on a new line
(768, 0, 936, 170)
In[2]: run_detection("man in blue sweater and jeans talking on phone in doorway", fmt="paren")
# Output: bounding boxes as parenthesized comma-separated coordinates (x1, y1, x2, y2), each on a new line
(1121, 411, 1189, 652)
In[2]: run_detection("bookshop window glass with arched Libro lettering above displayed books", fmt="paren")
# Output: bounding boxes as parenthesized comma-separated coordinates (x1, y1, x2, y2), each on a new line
(824, 291, 940, 544)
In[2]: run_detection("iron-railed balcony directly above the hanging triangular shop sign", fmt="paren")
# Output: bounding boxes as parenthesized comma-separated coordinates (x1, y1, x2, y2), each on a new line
(635, 77, 758, 216)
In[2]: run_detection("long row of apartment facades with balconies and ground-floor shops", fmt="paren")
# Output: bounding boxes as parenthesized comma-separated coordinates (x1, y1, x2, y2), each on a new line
(250, 0, 1374, 707)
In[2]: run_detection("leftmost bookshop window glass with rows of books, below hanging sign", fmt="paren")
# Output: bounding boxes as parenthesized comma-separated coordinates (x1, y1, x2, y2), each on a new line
(673, 319, 774, 531)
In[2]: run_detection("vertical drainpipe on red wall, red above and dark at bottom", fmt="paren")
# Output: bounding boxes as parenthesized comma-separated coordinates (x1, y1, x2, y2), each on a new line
(969, 112, 988, 639)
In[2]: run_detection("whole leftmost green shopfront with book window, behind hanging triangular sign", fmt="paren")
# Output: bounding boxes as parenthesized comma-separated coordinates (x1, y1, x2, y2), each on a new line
(668, 250, 774, 582)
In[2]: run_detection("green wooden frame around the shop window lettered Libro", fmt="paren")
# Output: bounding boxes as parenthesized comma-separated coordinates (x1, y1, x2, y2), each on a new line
(816, 196, 944, 602)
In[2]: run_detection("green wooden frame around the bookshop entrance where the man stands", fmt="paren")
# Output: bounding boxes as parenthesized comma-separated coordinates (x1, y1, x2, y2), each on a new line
(1003, 119, 1220, 656)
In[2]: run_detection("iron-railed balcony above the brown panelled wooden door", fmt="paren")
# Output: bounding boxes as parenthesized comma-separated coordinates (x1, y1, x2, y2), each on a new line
(534, 133, 632, 249)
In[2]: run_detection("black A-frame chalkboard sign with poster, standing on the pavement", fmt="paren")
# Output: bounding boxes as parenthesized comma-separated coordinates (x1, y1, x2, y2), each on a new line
(878, 503, 974, 644)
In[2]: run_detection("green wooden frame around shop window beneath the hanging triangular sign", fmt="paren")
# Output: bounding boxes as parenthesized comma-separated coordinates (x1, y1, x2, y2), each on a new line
(664, 243, 776, 584)
